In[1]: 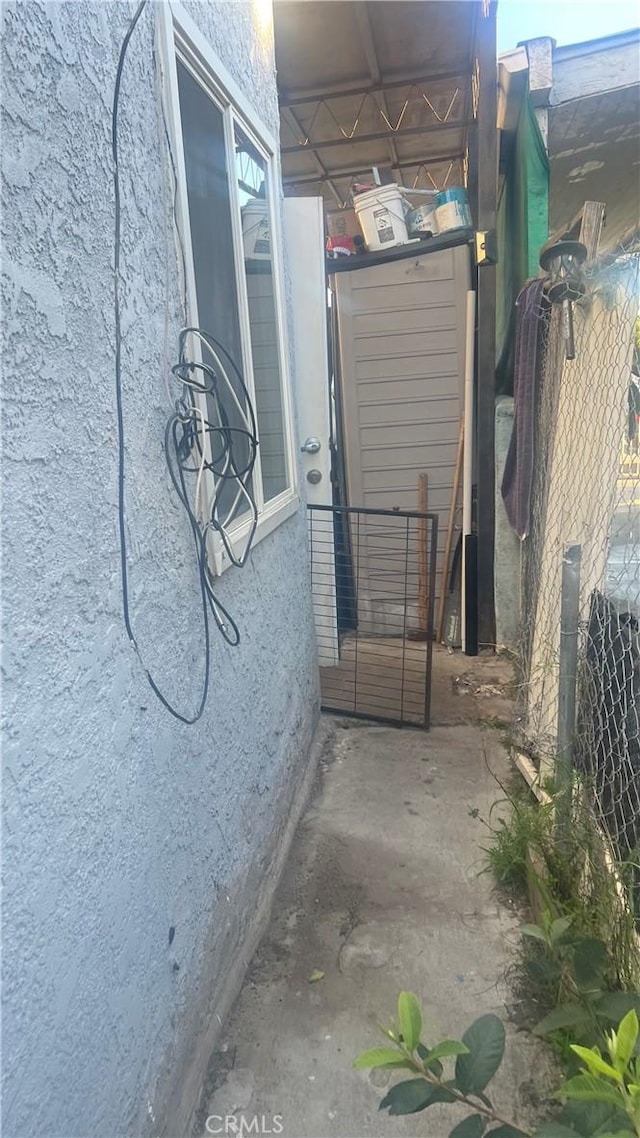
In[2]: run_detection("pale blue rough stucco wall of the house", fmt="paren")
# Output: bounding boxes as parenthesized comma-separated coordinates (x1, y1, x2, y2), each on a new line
(2, 0, 318, 1138)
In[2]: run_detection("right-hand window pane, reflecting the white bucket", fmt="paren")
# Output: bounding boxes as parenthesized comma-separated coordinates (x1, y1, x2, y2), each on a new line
(236, 126, 288, 502)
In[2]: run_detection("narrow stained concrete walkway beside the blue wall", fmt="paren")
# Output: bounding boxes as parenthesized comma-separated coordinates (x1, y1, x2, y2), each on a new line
(199, 660, 551, 1138)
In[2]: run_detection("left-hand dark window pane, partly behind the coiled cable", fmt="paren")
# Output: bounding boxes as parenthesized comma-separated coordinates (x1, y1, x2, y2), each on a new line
(178, 60, 249, 523)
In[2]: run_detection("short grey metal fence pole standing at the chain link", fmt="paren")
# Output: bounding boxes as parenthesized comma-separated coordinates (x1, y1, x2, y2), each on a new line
(556, 545, 582, 838)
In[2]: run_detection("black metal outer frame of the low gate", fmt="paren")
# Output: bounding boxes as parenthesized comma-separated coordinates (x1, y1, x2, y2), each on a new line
(307, 502, 438, 729)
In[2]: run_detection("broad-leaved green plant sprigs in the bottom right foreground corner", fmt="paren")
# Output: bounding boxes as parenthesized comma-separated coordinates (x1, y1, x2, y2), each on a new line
(354, 992, 640, 1138)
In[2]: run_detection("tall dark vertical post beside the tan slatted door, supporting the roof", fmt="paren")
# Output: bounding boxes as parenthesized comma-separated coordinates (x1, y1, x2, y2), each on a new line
(475, 0, 498, 646)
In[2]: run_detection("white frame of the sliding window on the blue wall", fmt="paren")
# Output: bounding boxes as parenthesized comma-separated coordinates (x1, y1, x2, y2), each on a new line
(156, 0, 300, 575)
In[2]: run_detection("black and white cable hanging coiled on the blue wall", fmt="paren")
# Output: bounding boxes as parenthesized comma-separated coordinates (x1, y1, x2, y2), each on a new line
(112, 0, 257, 724)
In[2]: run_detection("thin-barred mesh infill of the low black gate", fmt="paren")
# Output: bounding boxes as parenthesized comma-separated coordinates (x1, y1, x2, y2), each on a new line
(309, 505, 437, 727)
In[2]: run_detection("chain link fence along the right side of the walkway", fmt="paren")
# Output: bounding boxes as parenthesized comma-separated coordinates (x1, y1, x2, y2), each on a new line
(512, 235, 640, 916)
